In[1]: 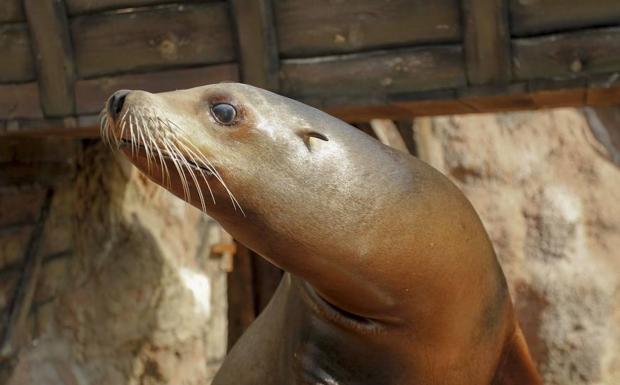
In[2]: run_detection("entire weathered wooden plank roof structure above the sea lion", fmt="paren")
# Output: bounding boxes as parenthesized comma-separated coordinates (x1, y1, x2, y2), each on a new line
(0, 0, 620, 134)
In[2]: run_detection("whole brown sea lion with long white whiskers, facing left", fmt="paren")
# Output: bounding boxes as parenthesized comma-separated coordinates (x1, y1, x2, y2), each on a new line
(102, 83, 541, 385)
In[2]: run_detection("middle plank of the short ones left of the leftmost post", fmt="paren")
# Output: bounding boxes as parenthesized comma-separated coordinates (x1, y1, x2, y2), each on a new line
(0, 23, 36, 83)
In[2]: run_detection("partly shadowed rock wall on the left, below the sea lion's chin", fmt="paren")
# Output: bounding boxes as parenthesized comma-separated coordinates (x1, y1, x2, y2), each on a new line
(0, 139, 227, 385)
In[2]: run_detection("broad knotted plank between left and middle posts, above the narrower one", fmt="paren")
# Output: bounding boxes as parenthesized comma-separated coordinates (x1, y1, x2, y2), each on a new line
(71, 3, 235, 78)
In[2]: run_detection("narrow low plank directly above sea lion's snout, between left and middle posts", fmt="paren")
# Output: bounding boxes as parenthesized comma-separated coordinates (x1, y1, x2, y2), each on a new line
(75, 64, 239, 114)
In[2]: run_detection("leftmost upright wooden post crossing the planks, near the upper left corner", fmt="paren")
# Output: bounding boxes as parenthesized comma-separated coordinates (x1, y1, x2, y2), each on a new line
(24, 0, 75, 117)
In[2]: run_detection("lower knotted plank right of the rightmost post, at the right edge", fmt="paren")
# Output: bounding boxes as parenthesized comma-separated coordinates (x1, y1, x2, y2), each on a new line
(512, 27, 620, 80)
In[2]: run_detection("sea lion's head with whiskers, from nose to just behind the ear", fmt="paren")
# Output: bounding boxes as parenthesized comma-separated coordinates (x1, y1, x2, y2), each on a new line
(102, 83, 406, 260)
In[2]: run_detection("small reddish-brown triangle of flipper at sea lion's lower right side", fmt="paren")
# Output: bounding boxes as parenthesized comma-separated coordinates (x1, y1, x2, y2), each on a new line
(491, 327, 543, 385)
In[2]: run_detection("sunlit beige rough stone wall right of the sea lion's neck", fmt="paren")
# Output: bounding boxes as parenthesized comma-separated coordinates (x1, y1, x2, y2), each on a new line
(416, 109, 620, 385)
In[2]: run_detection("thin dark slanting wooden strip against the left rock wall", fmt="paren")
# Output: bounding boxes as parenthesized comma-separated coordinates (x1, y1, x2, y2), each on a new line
(0, 189, 54, 360)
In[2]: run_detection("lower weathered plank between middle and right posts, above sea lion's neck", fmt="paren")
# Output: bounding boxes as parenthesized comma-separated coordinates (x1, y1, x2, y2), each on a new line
(280, 46, 465, 106)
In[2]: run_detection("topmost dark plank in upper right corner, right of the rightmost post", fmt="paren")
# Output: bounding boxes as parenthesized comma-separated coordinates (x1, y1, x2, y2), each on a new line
(510, 0, 620, 36)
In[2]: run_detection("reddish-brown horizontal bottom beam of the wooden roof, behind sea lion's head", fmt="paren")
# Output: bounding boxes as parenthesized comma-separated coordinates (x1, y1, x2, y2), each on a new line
(0, 80, 620, 137)
